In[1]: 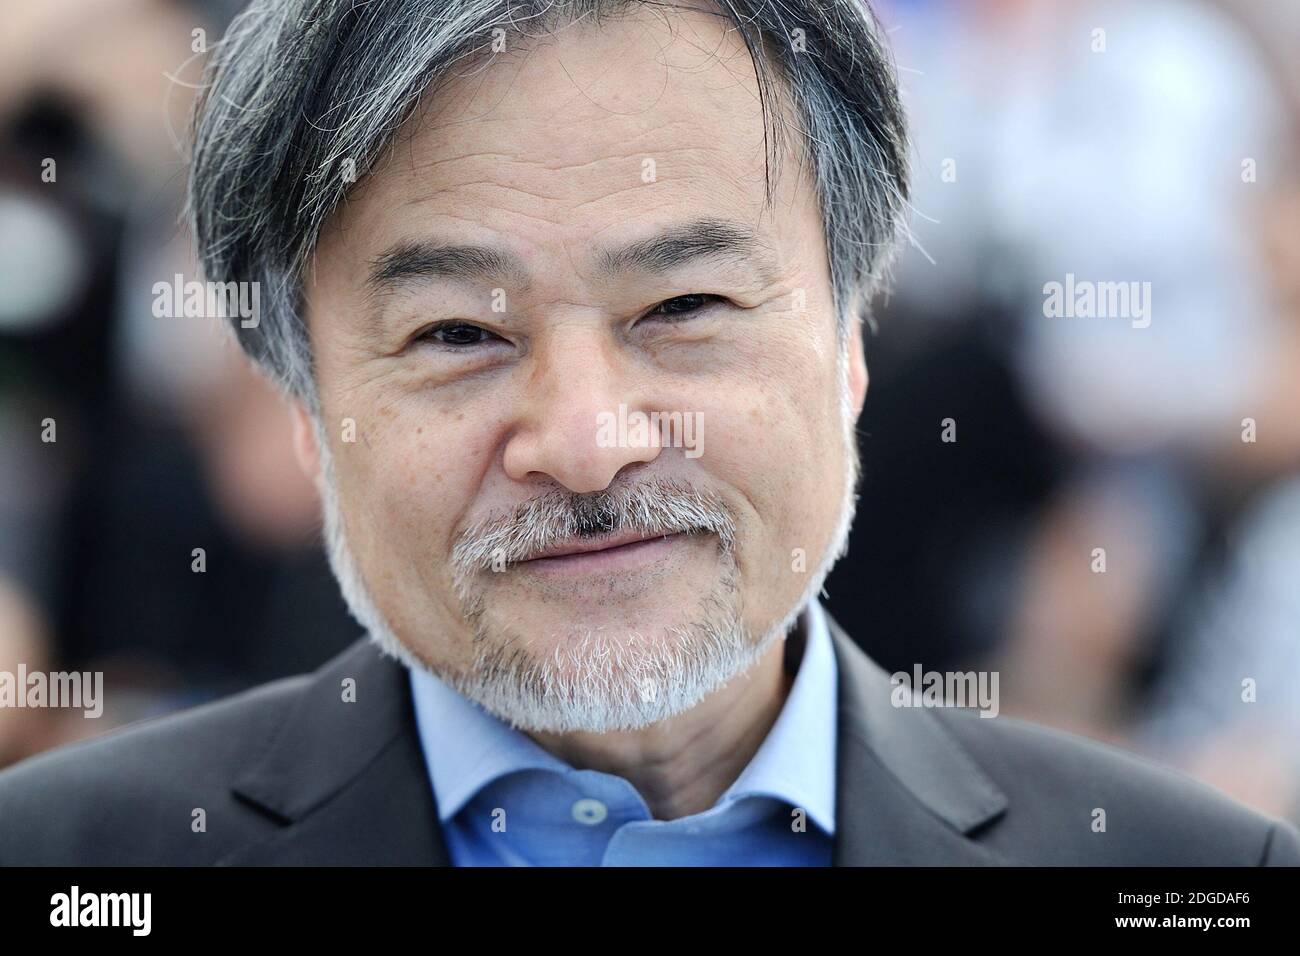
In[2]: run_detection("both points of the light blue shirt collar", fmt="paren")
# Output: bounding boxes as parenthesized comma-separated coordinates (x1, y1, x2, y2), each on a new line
(410, 598, 837, 834)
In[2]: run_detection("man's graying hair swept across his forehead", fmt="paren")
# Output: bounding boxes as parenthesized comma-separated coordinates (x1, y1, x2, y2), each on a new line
(187, 0, 909, 410)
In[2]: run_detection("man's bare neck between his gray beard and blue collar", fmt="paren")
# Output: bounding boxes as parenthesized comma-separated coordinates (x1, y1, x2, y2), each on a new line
(530, 640, 793, 819)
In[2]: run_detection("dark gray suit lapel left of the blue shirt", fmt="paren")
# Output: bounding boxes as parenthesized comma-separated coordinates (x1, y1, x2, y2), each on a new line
(220, 640, 450, 866)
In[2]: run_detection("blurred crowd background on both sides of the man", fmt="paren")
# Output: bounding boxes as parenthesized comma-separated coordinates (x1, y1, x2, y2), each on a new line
(0, 0, 1300, 822)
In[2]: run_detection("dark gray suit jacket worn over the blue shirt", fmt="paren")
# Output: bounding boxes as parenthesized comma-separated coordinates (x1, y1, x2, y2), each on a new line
(0, 619, 1300, 866)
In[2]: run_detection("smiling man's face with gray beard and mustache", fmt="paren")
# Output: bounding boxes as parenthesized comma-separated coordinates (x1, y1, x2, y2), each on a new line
(295, 5, 866, 728)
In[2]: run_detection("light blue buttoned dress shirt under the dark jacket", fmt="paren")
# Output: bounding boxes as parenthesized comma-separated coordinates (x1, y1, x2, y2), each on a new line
(411, 598, 837, 866)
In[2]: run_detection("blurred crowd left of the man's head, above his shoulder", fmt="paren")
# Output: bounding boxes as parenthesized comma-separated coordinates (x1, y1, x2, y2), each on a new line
(0, 0, 360, 765)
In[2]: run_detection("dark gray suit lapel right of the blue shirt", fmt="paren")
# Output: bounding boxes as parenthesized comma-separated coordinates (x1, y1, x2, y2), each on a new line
(827, 614, 1006, 866)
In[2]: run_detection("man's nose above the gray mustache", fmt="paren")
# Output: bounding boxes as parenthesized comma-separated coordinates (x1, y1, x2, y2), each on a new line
(504, 326, 660, 493)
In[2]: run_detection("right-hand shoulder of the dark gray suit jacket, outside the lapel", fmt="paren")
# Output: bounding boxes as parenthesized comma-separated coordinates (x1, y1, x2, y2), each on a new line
(931, 709, 1300, 866)
